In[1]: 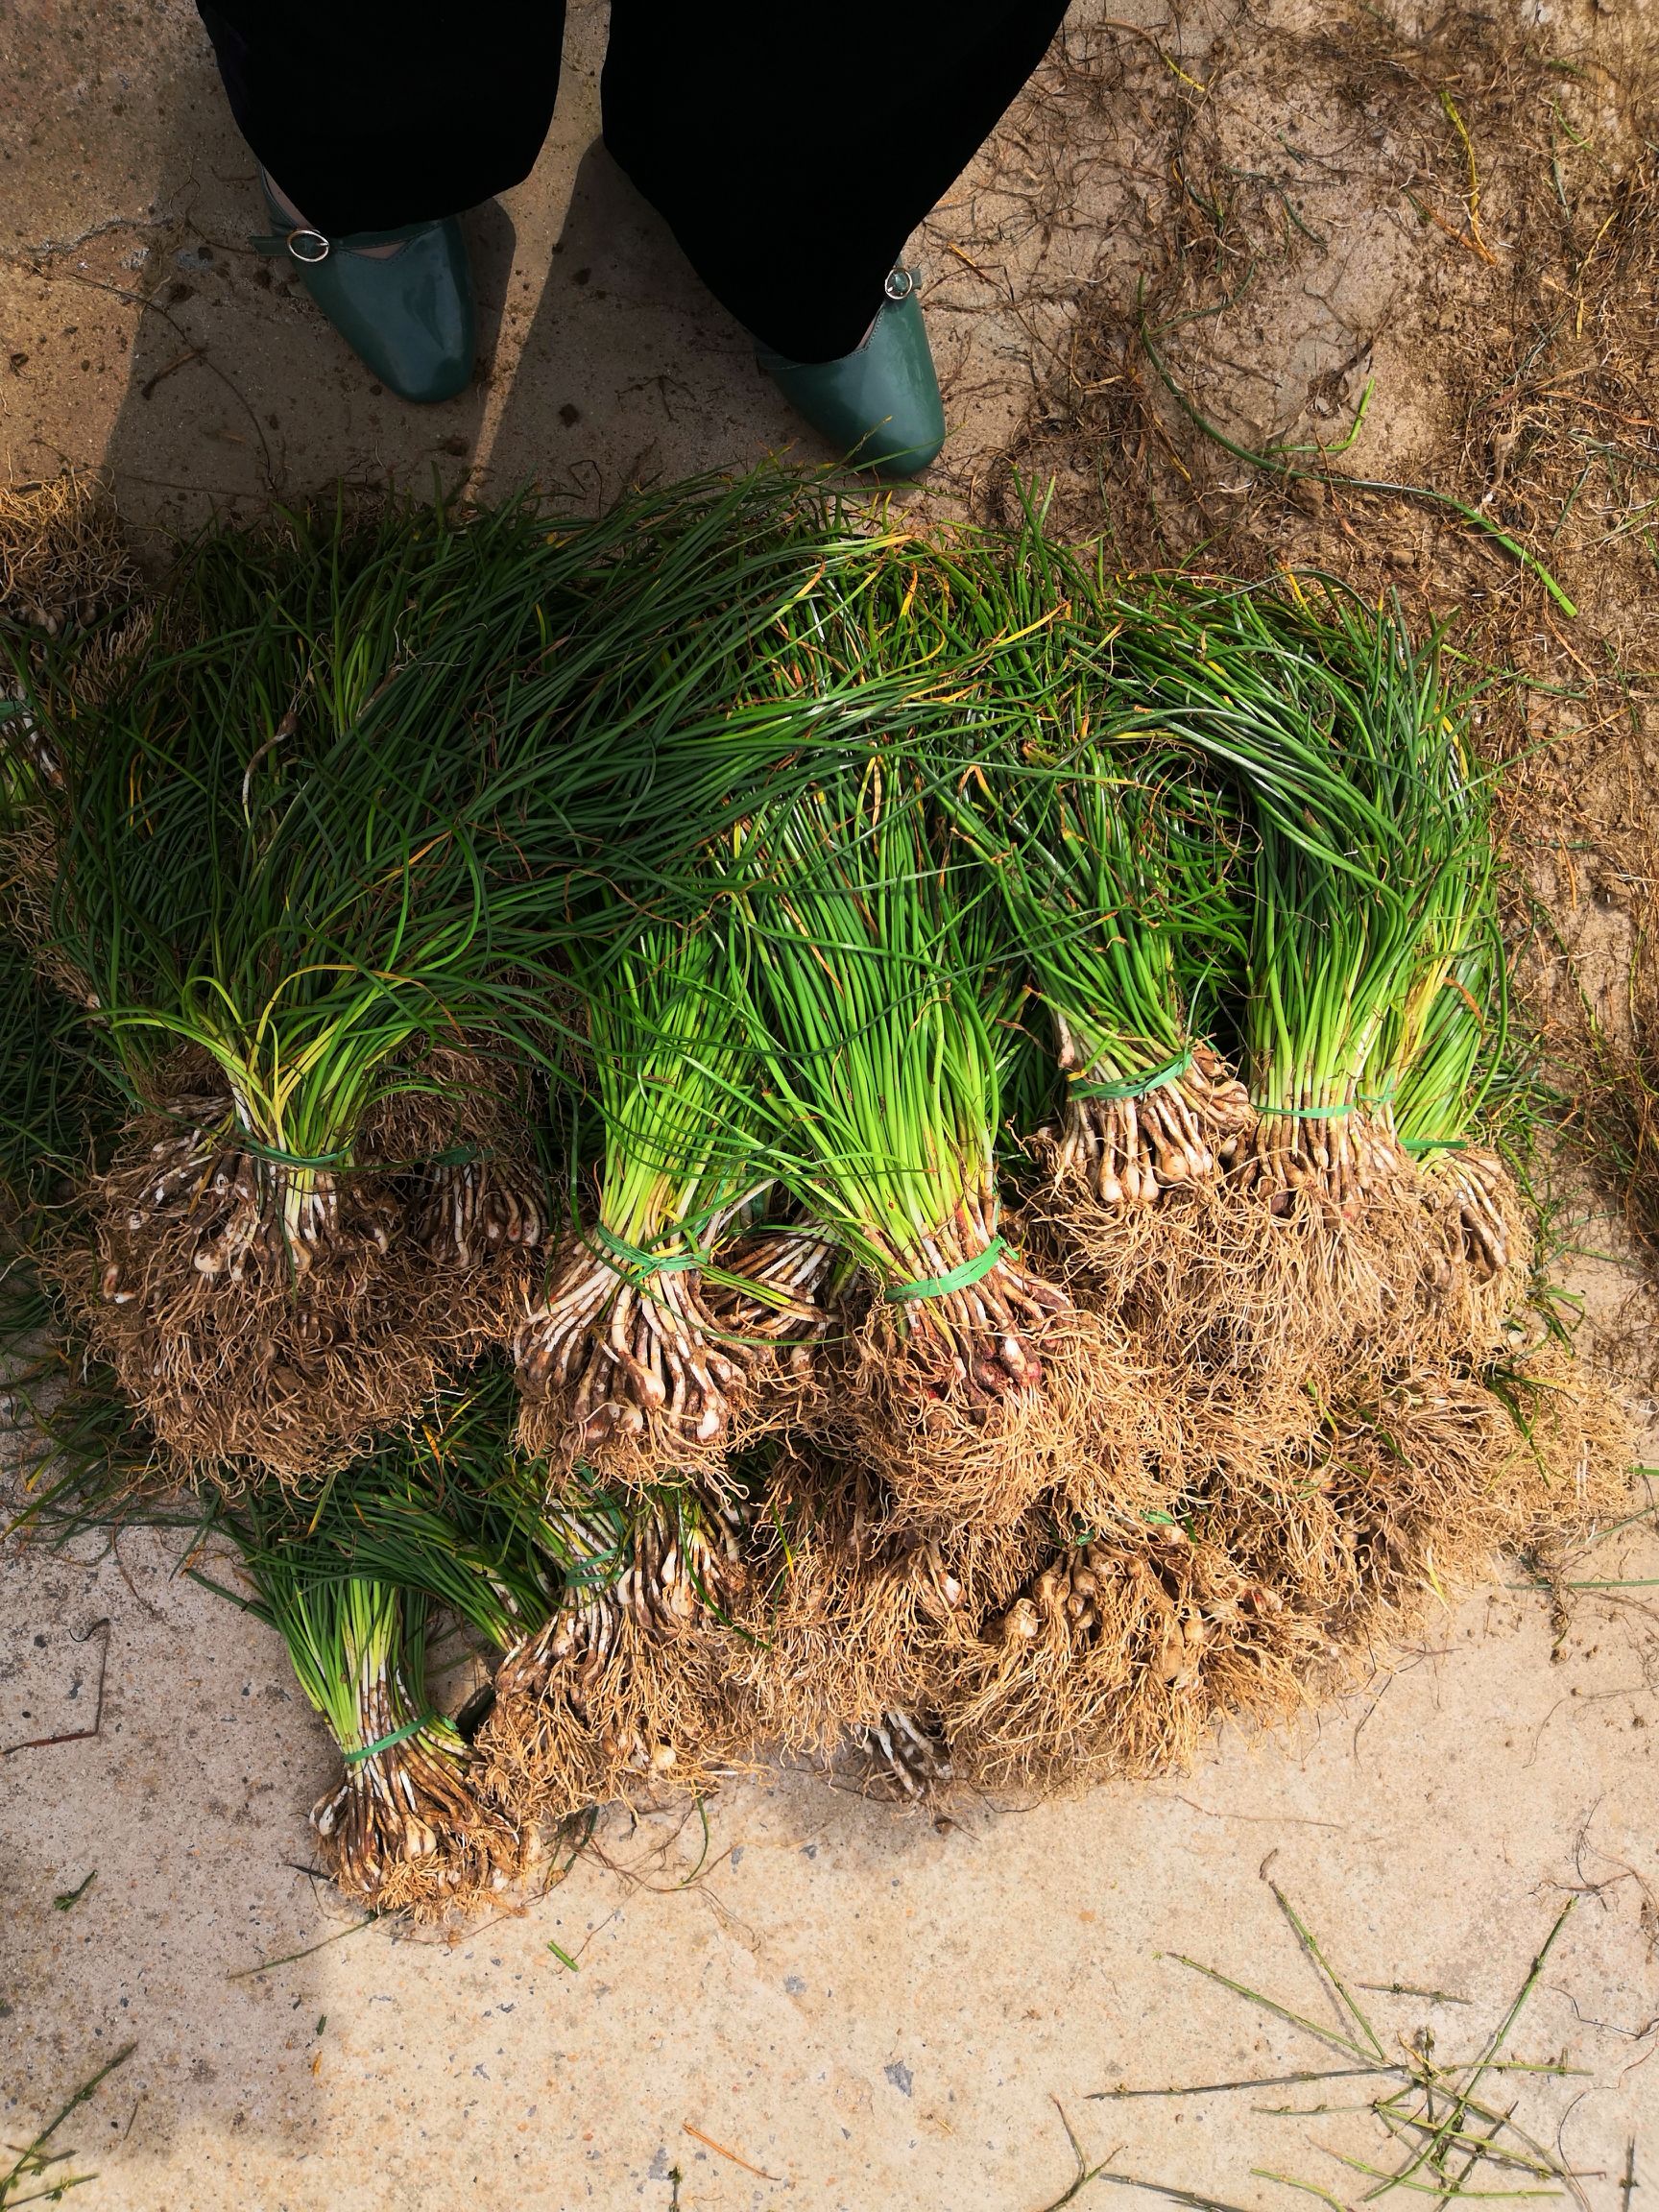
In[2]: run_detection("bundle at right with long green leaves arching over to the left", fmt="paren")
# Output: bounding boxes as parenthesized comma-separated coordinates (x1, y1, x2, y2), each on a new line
(1070, 587, 1530, 1387)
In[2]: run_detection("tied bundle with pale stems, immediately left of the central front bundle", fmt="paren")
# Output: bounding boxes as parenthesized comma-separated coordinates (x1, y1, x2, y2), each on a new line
(514, 909, 830, 1484)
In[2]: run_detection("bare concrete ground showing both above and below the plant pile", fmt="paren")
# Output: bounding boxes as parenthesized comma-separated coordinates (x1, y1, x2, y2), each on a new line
(0, 0, 1659, 2212)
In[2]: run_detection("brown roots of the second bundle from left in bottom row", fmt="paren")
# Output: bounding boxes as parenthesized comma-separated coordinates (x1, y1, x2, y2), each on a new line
(478, 1486, 750, 1820)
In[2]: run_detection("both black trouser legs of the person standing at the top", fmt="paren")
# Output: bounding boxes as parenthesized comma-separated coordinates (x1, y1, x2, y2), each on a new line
(197, 0, 1067, 361)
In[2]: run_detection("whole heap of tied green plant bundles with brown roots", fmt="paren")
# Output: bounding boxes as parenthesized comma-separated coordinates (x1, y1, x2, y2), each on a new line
(0, 475, 1623, 1913)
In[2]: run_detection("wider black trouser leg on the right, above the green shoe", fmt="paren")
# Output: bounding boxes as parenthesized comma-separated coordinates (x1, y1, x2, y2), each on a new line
(604, 0, 1067, 361)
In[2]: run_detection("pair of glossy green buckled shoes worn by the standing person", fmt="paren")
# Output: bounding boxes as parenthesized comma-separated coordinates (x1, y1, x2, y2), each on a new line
(252, 170, 945, 480)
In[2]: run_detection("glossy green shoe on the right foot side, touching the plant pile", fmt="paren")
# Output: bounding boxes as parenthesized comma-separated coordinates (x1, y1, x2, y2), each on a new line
(755, 270, 945, 478)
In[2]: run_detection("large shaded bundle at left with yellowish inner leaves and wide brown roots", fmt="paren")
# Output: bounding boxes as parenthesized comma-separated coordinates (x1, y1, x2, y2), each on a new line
(1, 495, 584, 1478)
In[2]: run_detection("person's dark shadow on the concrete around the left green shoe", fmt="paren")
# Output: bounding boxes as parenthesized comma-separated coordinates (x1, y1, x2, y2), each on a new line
(84, 17, 830, 541)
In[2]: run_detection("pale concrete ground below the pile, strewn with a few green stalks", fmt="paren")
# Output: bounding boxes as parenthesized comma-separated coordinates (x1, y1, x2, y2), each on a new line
(0, 1512, 1659, 2212)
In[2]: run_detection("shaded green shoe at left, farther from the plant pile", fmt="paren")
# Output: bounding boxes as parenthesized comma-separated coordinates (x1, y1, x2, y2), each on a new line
(252, 170, 478, 405)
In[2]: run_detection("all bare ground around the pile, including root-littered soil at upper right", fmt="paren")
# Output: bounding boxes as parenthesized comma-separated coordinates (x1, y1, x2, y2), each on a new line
(0, 0, 1659, 2212)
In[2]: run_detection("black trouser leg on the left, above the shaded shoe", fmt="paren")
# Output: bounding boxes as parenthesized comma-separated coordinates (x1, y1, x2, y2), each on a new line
(197, 0, 565, 237)
